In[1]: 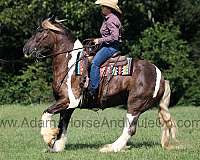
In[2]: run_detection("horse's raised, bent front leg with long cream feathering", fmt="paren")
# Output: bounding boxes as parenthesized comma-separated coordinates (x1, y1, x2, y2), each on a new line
(41, 99, 73, 149)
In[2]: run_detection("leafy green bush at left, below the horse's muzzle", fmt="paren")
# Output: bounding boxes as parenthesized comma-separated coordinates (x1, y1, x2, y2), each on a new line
(0, 63, 52, 104)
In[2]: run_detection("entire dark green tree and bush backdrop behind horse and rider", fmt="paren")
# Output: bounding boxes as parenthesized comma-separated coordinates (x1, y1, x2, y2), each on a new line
(0, 0, 200, 105)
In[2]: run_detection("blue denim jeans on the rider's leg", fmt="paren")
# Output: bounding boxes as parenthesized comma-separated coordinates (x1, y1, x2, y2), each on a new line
(89, 47, 118, 93)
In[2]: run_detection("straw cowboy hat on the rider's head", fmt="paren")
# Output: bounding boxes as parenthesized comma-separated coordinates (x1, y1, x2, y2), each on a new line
(95, 0, 122, 14)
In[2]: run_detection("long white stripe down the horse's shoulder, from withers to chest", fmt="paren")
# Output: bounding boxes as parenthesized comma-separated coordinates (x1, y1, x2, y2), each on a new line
(67, 40, 83, 108)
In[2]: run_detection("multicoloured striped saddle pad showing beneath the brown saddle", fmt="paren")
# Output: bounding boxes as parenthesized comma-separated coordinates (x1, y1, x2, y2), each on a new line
(75, 52, 132, 77)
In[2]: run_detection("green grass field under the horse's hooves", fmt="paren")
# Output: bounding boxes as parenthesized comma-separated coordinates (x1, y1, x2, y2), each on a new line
(0, 105, 200, 160)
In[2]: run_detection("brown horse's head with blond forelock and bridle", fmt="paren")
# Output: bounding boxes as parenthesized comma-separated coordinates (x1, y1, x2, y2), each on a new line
(23, 17, 64, 57)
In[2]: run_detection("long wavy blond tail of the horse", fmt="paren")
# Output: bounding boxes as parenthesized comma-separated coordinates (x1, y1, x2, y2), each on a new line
(159, 80, 177, 149)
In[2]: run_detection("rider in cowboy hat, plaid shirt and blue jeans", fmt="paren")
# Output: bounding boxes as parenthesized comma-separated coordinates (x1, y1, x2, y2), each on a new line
(88, 0, 122, 99)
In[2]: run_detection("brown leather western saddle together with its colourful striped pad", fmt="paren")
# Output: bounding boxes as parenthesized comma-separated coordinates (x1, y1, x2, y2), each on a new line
(78, 52, 132, 109)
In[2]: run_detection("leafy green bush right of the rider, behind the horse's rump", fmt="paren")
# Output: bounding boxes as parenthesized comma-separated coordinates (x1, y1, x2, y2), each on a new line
(132, 23, 196, 104)
